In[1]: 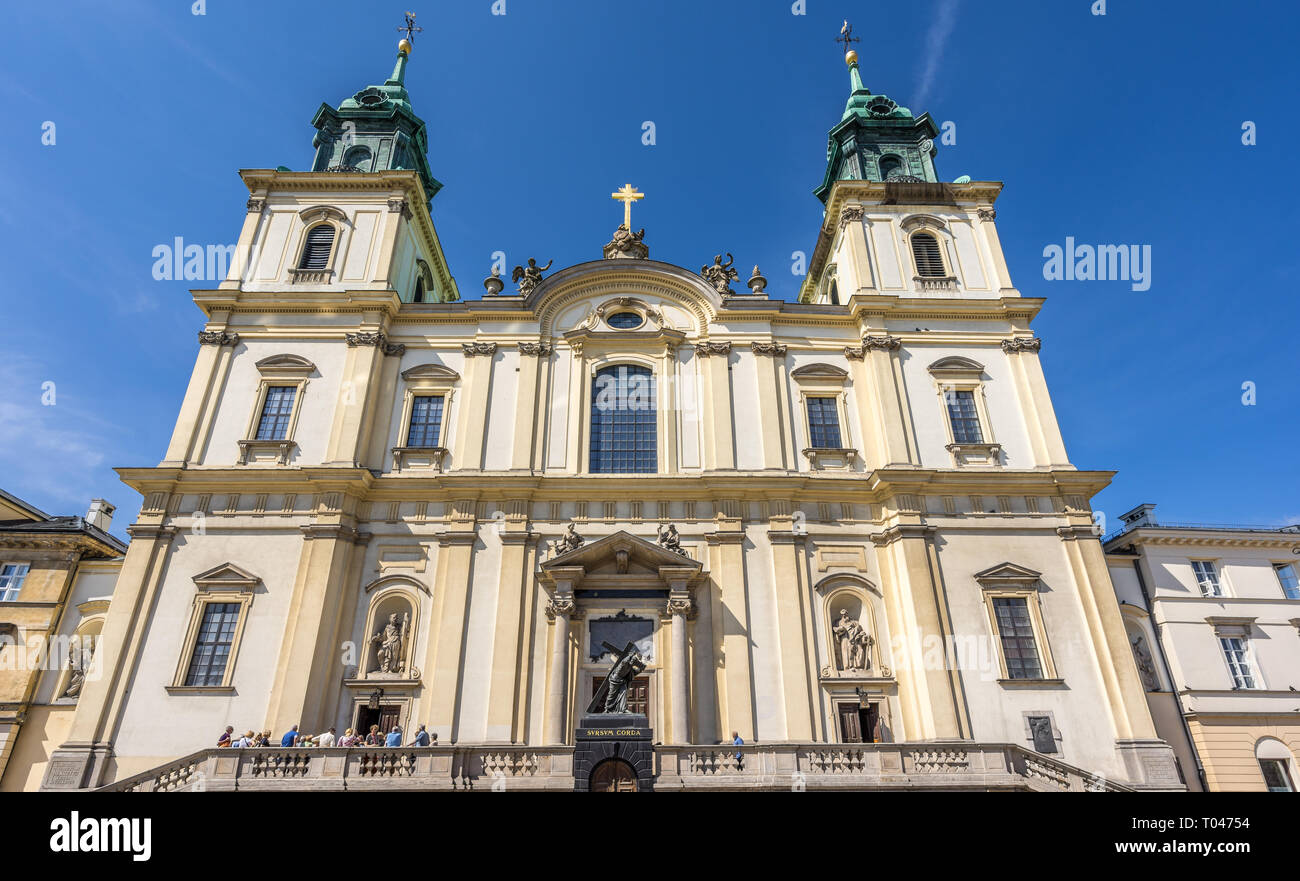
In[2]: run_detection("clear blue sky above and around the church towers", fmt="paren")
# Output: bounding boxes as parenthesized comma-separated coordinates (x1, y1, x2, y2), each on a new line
(0, 0, 1300, 534)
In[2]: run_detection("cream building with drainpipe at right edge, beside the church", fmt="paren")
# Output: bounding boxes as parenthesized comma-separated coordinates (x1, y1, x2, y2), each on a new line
(1105, 504, 1300, 793)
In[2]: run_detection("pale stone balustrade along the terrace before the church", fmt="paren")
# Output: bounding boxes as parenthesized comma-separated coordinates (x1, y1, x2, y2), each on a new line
(100, 741, 1131, 793)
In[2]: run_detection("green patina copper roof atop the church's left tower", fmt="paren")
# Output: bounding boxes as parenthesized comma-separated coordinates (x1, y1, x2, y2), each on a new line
(312, 52, 442, 199)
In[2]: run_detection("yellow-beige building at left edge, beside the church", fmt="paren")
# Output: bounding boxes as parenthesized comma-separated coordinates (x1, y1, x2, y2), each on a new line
(0, 490, 126, 791)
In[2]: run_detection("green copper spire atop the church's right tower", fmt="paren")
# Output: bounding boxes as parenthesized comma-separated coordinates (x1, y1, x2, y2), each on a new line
(813, 21, 939, 204)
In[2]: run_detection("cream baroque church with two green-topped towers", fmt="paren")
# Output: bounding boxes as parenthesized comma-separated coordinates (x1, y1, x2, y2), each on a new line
(32, 25, 1183, 790)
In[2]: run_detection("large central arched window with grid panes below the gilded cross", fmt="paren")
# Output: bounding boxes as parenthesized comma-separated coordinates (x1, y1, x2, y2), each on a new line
(590, 364, 659, 474)
